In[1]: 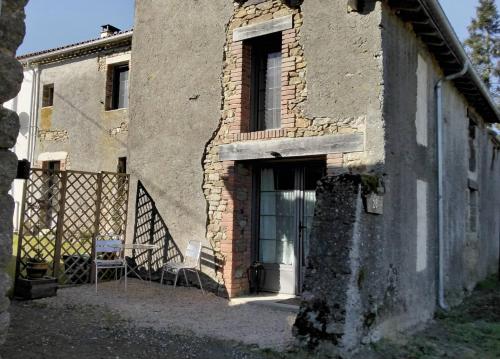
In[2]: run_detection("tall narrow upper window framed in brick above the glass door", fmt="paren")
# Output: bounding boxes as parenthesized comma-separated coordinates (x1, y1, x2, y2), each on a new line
(250, 32, 281, 131)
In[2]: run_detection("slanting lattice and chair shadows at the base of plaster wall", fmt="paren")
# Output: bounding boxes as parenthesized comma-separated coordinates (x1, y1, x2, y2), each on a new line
(128, 181, 227, 296)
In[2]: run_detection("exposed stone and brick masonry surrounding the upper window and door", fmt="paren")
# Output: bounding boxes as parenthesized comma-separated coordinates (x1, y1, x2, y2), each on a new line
(203, 0, 365, 296)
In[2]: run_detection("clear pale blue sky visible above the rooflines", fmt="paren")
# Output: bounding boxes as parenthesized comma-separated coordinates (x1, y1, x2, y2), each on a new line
(17, 0, 500, 54)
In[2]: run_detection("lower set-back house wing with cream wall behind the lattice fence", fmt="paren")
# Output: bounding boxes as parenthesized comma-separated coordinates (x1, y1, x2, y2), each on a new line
(5, 25, 132, 231)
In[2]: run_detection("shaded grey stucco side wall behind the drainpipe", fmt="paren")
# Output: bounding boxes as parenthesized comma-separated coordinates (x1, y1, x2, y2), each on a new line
(378, 6, 499, 337)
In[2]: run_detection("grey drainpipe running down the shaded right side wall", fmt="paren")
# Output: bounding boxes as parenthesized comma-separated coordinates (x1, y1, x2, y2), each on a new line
(436, 61, 470, 310)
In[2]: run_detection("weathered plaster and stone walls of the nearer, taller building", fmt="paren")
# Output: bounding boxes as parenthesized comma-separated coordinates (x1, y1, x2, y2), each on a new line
(128, 0, 500, 352)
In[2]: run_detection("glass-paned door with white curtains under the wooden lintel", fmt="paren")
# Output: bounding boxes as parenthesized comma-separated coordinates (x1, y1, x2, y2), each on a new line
(257, 166, 323, 294)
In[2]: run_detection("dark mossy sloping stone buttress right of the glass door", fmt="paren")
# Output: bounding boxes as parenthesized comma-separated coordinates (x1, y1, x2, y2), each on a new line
(294, 175, 363, 354)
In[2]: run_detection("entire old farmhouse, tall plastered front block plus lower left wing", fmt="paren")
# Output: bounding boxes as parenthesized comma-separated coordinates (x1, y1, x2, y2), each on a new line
(5, 0, 500, 350)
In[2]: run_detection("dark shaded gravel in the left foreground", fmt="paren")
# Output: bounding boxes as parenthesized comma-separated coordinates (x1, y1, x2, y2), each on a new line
(0, 301, 283, 359)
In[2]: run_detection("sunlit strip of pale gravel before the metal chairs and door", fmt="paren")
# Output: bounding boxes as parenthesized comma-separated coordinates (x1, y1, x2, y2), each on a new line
(25, 279, 295, 350)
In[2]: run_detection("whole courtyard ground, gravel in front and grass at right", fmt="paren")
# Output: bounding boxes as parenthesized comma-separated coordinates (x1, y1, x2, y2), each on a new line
(0, 277, 500, 359)
